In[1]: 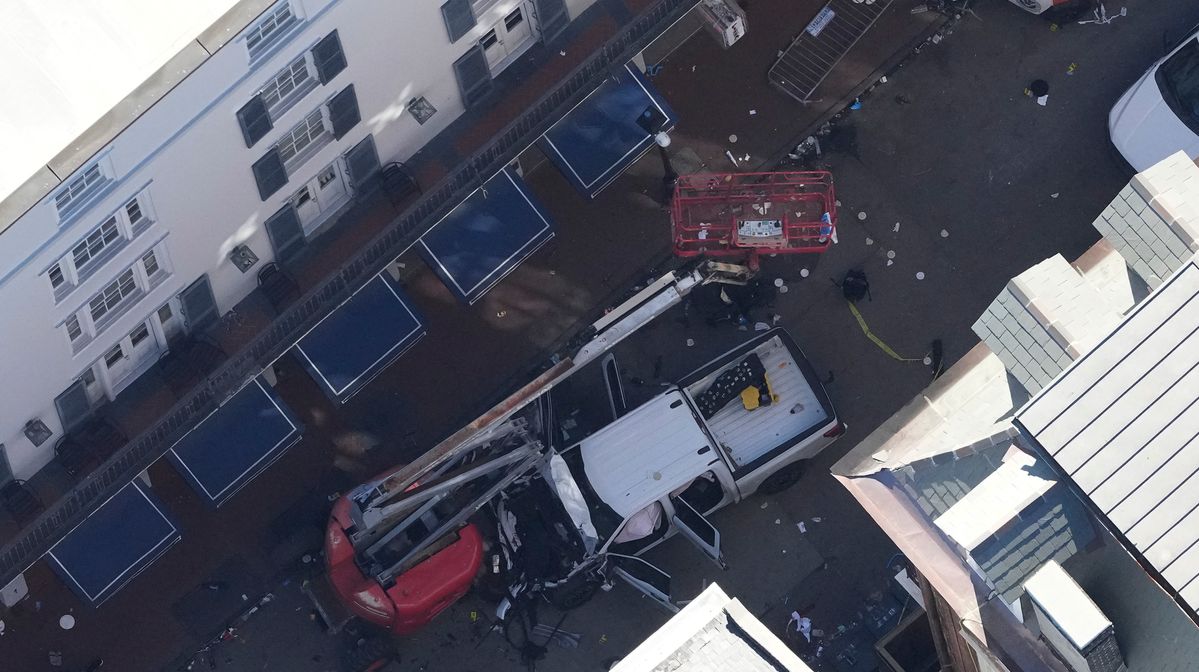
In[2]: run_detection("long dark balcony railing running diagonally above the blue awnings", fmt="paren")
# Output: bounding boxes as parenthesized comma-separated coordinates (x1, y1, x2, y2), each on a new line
(0, 0, 698, 586)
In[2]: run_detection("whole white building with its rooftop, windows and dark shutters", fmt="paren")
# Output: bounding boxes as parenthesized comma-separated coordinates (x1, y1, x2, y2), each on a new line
(0, 0, 594, 480)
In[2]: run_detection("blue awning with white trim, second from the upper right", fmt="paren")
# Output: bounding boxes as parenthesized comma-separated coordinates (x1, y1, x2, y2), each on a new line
(421, 168, 554, 304)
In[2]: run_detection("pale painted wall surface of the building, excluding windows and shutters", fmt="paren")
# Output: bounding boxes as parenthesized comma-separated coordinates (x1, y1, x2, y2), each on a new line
(0, 0, 594, 478)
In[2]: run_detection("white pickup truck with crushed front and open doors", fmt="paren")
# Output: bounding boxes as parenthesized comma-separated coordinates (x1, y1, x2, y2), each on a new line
(494, 329, 844, 611)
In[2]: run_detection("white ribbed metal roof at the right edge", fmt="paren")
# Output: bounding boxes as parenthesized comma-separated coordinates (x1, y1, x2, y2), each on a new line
(1017, 260, 1199, 613)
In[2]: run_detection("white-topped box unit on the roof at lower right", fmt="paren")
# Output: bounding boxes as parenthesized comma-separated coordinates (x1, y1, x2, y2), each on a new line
(1024, 560, 1127, 672)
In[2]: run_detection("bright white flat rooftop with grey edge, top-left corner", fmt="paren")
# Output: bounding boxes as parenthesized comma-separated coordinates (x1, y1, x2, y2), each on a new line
(0, 0, 261, 232)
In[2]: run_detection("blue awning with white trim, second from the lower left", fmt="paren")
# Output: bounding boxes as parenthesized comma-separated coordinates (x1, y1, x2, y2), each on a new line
(169, 378, 302, 506)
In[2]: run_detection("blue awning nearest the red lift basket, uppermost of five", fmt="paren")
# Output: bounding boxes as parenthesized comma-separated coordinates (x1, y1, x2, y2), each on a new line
(541, 64, 677, 198)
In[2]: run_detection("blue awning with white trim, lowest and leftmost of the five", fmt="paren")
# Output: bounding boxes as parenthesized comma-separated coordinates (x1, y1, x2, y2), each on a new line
(46, 481, 180, 606)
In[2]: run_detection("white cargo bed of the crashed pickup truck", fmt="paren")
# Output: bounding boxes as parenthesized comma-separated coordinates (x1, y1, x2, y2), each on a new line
(686, 330, 832, 468)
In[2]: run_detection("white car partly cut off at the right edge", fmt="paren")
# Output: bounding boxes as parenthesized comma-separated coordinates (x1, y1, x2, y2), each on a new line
(1108, 32, 1199, 173)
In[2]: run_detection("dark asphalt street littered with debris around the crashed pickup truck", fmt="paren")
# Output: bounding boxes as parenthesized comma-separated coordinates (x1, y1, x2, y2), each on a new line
(171, 0, 1199, 672)
